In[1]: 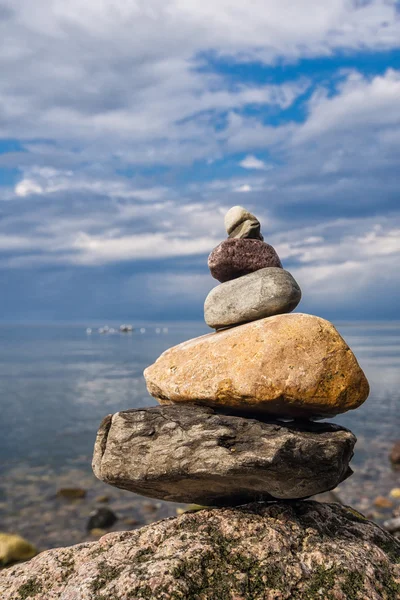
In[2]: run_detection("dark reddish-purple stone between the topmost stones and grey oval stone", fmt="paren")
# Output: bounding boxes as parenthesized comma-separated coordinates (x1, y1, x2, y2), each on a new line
(208, 239, 282, 282)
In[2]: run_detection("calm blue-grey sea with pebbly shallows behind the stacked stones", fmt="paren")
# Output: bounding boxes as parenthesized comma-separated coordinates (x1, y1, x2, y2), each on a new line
(0, 322, 400, 549)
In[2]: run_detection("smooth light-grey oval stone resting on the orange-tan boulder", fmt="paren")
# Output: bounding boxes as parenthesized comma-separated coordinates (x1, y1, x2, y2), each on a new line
(204, 267, 301, 329)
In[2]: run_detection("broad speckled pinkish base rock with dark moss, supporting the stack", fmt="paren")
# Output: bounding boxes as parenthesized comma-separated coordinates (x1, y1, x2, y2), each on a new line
(0, 502, 400, 600)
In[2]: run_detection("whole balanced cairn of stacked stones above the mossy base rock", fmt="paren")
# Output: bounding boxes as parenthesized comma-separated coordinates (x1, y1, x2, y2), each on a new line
(93, 206, 369, 506)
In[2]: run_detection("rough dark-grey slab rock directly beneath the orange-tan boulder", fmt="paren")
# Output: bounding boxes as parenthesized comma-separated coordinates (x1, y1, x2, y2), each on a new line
(93, 405, 356, 506)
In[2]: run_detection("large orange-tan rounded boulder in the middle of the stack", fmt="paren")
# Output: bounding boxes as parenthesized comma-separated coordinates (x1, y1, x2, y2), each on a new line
(144, 314, 369, 418)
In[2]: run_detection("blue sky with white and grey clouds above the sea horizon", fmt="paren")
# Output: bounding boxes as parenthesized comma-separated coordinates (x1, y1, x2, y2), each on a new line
(0, 0, 400, 322)
